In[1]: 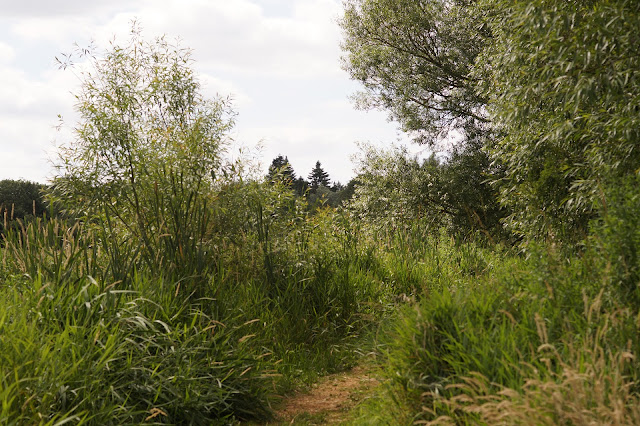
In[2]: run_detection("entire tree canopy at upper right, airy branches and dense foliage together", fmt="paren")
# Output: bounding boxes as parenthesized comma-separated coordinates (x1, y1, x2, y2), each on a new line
(342, 0, 640, 243)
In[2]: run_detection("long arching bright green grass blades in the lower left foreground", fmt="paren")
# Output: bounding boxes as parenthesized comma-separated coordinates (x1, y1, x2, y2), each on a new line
(0, 277, 269, 424)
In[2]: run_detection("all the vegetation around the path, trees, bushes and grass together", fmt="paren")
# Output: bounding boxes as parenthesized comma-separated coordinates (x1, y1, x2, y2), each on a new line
(0, 0, 640, 425)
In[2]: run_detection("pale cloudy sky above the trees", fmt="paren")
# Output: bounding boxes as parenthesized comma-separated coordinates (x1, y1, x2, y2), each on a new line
(0, 0, 416, 183)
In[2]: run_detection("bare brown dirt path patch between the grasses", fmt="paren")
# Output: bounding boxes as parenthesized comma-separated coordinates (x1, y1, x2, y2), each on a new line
(272, 366, 379, 425)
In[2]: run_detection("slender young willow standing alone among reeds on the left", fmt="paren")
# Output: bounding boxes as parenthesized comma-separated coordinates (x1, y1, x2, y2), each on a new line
(55, 28, 234, 272)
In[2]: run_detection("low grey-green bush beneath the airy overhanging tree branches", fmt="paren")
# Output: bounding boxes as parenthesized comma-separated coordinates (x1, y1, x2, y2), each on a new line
(349, 141, 505, 240)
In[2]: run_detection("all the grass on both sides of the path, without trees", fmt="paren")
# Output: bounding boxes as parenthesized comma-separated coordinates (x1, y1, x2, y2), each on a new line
(0, 181, 640, 425)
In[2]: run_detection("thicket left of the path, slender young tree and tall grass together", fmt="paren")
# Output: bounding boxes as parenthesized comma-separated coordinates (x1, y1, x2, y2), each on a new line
(0, 31, 384, 424)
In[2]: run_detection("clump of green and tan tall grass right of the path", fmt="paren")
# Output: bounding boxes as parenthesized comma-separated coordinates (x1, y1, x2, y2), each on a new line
(354, 231, 640, 424)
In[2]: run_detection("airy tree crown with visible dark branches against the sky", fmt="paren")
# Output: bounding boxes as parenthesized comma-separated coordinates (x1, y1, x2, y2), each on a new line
(341, 0, 490, 143)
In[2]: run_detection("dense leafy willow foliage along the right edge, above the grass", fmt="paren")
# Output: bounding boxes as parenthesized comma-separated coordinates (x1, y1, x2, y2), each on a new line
(479, 0, 640, 240)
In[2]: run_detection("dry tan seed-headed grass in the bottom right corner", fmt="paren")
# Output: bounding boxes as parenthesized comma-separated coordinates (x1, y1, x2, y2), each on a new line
(419, 298, 640, 426)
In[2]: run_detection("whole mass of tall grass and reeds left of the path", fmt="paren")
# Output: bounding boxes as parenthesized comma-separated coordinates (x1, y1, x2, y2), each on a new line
(0, 184, 398, 424)
